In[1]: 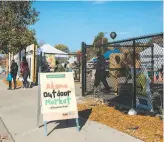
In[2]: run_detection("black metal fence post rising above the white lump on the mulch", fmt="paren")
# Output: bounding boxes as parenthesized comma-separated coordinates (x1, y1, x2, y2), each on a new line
(132, 39, 136, 109)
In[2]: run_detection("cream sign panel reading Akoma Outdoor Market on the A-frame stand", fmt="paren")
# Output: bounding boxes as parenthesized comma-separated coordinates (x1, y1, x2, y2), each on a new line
(40, 72, 78, 121)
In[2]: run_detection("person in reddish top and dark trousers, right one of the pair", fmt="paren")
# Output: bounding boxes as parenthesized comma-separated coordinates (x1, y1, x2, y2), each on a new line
(20, 56, 30, 88)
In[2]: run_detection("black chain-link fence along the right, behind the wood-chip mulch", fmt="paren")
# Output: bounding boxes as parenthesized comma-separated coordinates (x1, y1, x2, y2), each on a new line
(82, 33, 163, 110)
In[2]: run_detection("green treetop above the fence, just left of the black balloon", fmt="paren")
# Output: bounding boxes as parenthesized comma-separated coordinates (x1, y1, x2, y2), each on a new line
(93, 32, 108, 47)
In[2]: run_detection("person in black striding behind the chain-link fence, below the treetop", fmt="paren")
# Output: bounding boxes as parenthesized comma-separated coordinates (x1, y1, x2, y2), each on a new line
(94, 51, 110, 92)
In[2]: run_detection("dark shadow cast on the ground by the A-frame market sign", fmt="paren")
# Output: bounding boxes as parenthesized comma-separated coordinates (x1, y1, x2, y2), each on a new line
(47, 109, 92, 135)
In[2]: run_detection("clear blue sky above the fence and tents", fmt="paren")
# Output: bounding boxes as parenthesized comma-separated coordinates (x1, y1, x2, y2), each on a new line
(32, 1, 163, 51)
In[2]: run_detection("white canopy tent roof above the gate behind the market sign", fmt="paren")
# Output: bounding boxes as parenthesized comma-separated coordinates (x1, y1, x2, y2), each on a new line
(40, 44, 68, 58)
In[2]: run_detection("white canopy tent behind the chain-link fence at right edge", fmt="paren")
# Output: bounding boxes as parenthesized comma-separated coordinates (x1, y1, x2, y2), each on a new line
(140, 43, 164, 68)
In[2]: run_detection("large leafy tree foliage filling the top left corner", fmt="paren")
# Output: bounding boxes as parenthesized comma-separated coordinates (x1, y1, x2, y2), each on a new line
(0, 1, 39, 53)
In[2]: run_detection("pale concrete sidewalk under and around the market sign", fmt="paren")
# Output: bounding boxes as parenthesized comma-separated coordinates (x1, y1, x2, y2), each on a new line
(0, 81, 141, 142)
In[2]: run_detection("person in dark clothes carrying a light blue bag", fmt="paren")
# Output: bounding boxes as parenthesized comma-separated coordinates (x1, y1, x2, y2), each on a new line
(8, 60, 18, 90)
